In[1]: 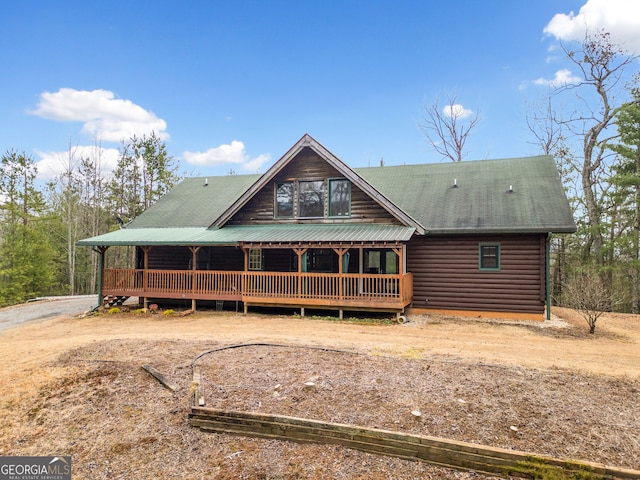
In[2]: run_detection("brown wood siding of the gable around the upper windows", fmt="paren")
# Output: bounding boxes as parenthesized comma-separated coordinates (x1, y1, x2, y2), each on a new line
(228, 148, 401, 225)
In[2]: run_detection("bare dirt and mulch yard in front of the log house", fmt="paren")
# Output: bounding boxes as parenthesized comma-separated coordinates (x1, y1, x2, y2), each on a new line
(0, 309, 640, 479)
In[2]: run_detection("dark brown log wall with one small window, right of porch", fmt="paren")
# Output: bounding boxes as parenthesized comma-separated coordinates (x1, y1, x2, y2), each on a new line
(407, 235, 545, 313)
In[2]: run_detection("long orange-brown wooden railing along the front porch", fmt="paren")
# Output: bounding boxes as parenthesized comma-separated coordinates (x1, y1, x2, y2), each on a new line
(102, 269, 413, 308)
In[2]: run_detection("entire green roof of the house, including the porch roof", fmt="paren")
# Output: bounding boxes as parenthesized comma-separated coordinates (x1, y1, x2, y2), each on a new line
(78, 149, 576, 246)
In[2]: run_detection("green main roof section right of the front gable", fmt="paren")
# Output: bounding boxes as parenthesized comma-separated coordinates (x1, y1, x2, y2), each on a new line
(354, 156, 576, 234)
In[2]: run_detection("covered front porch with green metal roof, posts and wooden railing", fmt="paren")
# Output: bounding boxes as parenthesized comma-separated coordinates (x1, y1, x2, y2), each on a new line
(82, 224, 413, 316)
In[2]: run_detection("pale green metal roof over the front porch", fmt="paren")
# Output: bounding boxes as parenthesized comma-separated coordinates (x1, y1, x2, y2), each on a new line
(77, 224, 415, 246)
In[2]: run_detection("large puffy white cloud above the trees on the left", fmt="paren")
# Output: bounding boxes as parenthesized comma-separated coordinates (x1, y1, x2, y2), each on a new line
(29, 88, 169, 142)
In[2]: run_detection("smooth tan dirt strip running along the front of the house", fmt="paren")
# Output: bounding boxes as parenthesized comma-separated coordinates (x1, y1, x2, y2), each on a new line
(0, 309, 640, 378)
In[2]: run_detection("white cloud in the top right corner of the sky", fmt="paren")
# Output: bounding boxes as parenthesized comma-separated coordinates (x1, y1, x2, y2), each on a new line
(544, 0, 640, 53)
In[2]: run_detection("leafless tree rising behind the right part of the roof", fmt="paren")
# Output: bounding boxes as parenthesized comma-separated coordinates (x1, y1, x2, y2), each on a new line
(419, 94, 479, 162)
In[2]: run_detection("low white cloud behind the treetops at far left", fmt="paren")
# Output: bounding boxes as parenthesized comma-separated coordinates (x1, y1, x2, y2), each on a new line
(36, 145, 120, 180)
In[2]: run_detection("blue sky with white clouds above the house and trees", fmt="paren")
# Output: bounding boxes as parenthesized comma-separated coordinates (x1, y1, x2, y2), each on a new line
(0, 0, 640, 178)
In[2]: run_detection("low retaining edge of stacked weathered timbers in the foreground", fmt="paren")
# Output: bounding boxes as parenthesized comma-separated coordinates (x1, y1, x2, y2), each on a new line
(189, 406, 640, 479)
